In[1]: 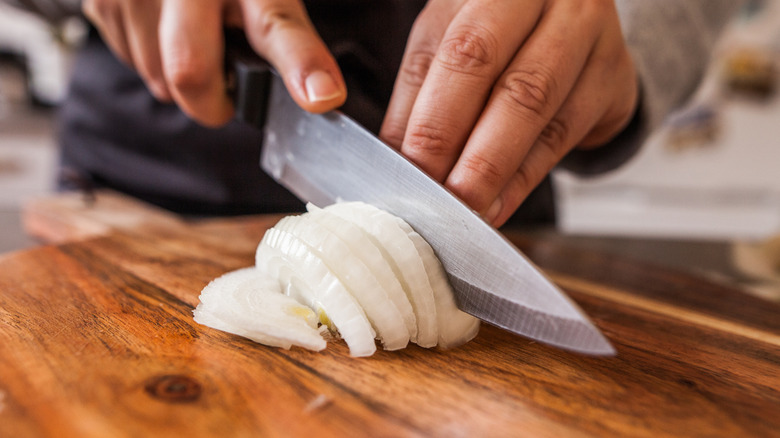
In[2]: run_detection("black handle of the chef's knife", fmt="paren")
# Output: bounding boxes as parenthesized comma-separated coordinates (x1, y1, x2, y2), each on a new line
(225, 29, 274, 129)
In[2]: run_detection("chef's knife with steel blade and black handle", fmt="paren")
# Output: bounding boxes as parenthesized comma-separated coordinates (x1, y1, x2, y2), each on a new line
(226, 35, 615, 355)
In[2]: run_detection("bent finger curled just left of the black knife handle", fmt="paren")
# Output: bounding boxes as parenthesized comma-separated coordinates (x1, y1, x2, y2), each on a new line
(159, 0, 234, 126)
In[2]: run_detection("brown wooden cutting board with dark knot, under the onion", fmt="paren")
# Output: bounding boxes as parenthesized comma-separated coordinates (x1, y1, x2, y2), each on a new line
(0, 194, 780, 437)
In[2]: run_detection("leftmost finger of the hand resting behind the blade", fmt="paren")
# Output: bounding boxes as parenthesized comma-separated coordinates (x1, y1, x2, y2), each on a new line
(379, 1, 463, 149)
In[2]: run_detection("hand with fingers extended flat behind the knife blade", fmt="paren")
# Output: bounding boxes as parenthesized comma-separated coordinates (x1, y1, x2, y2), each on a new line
(380, 0, 638, 226)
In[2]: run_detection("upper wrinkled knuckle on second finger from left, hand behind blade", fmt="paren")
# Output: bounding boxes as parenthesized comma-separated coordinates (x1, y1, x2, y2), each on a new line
(439, 26, 499, 72)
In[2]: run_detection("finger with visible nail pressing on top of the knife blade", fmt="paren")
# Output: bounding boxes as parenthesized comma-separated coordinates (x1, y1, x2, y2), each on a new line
(241, 0, 347, 112)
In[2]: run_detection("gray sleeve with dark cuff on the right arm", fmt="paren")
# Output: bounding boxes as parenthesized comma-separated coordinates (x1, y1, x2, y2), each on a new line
(561, 0, 746, 175)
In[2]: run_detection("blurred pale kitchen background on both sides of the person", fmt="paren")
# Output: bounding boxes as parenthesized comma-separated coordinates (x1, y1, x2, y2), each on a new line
(0, 1, 780, 301)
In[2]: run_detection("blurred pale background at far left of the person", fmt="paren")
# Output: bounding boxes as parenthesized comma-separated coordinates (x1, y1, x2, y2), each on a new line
(0, 3, 78, 254)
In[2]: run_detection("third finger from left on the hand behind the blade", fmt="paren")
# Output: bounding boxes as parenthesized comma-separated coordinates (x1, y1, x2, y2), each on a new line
(446, 2, 598, 216)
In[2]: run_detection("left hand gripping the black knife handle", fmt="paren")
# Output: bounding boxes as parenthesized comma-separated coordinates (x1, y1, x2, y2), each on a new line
(82, 0, 346, 126)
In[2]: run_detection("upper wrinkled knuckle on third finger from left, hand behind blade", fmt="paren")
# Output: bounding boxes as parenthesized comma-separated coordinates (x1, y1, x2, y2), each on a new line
(498, 67, 557, 116)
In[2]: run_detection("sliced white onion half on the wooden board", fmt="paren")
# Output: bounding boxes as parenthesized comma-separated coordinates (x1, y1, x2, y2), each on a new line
(193, 202, 479, 357)
